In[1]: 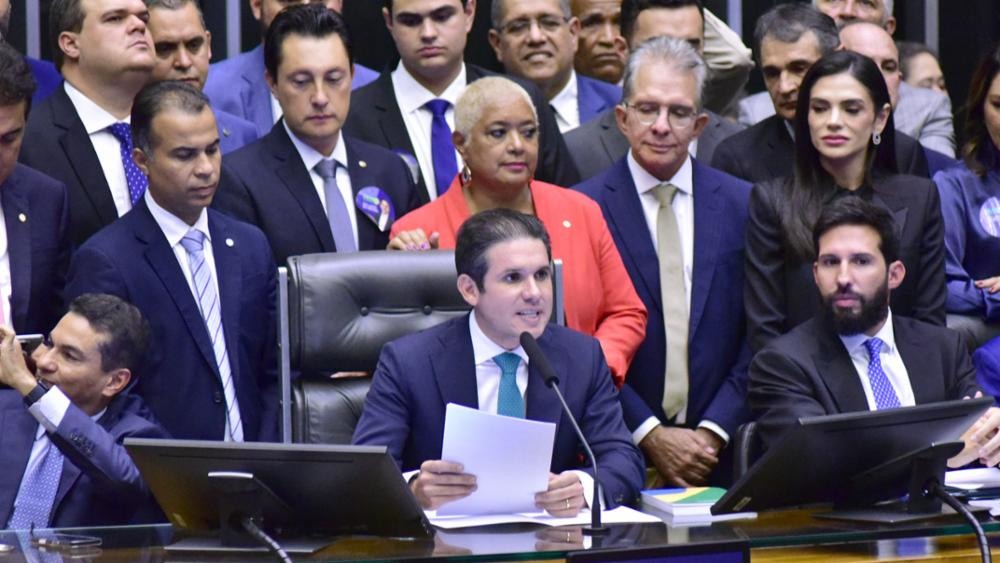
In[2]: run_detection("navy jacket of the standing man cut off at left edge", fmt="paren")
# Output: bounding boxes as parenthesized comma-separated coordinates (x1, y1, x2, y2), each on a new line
(0, 164, 70, 333)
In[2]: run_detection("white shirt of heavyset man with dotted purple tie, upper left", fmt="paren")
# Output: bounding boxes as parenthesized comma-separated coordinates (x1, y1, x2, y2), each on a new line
(62, 81, 132, 217)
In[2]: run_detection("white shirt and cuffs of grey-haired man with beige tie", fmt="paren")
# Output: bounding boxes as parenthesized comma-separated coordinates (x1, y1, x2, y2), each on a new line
(627, 150, 729, 445)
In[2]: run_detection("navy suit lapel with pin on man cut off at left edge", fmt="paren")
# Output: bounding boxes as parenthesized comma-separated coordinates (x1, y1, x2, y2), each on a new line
(0, 181, 32, 327)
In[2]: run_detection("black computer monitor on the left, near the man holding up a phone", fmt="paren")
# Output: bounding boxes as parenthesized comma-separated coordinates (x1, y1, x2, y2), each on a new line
(125, 438, 432, 545)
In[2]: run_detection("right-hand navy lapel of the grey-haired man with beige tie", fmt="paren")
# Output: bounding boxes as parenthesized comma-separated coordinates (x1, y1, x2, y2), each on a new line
(688, 160, 725, 339)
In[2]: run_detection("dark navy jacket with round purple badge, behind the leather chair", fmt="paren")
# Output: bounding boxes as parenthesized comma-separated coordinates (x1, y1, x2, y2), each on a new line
(212, 122, 417, 264)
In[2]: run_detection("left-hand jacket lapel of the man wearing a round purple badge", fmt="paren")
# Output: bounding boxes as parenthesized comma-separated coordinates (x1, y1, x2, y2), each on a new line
(267, 128, 337, 252)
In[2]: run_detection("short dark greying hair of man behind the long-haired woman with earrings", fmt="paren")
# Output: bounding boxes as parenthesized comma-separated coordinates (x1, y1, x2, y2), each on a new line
(753, 2, 840, 66)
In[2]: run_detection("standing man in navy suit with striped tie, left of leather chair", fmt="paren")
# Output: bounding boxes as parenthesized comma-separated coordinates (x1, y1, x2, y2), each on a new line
(66, 81, 278, 441)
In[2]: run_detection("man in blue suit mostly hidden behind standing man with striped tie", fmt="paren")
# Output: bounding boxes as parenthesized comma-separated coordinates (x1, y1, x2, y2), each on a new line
(145, 0, 257, 154)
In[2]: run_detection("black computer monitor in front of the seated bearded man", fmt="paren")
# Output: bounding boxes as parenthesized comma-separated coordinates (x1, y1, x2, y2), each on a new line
(712, 397, 993, 514)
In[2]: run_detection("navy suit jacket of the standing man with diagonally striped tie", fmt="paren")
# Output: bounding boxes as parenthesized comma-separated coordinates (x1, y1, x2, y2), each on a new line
(66, 204, 278, 441)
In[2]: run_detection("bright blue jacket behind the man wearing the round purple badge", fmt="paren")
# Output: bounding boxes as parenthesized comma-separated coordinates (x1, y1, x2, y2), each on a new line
(205, 45, 378, 137)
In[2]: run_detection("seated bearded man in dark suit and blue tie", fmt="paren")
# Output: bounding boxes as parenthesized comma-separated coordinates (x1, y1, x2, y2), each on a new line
(749, 196, 1000, 467)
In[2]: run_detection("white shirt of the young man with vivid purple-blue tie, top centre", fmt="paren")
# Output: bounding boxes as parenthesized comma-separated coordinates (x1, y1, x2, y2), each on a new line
(391, 62, 467, 201)
